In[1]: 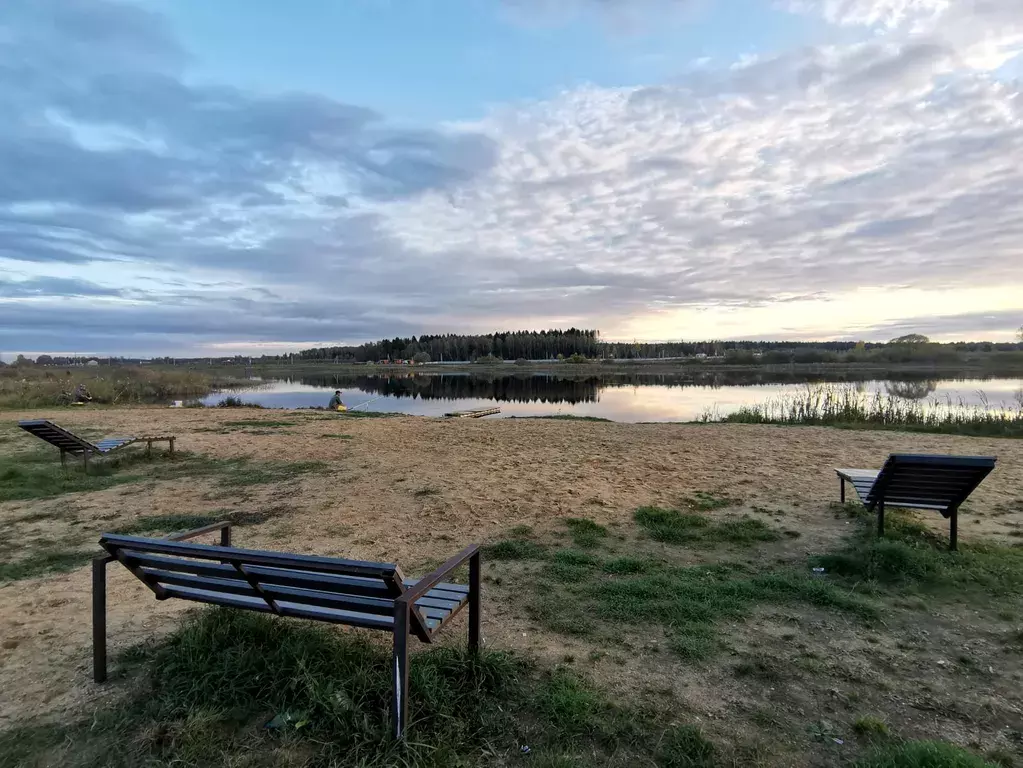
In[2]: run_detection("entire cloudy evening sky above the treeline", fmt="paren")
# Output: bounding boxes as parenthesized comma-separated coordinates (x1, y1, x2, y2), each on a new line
(0, 0, 1023, 356)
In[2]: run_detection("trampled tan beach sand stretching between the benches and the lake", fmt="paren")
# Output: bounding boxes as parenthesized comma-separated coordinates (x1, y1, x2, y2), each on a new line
(0, 408, 1023, 740)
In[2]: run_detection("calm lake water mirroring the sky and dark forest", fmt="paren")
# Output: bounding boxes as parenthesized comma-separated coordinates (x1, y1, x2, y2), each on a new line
(204, 371, 1023, 421)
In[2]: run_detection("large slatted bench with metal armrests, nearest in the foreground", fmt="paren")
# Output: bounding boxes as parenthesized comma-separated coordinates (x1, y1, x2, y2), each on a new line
(92, 523, 480, 738)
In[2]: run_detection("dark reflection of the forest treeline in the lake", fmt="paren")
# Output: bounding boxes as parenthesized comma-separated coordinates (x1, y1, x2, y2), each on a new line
(288, 370, 973, 403)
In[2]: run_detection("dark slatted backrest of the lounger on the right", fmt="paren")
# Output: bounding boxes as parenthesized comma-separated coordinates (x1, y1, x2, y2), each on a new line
(866, 453, 995, 517)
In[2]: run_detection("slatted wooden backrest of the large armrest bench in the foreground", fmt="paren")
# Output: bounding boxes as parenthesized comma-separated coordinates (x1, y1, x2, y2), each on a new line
(99, 534, 429, 638)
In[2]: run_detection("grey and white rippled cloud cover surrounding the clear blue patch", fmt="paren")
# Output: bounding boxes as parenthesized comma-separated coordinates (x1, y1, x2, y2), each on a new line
(0, 0, 1023, 354)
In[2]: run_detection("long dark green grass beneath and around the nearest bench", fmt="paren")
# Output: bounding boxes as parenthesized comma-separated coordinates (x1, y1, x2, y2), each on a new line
(0, 608, 718, 768)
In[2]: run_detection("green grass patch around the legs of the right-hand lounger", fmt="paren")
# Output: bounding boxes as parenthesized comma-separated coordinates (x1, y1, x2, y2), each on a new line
(817, 508, 1023, 595)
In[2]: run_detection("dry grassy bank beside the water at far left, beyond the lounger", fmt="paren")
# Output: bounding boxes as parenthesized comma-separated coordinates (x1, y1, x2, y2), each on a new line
(0, 365, 246, 408)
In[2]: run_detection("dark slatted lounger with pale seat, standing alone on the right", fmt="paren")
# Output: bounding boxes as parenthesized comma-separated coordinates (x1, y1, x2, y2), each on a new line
(835, 453, 996, 550)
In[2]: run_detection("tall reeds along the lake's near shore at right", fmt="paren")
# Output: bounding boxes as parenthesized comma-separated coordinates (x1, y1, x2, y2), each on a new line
(720, 386, 1023, 438)
